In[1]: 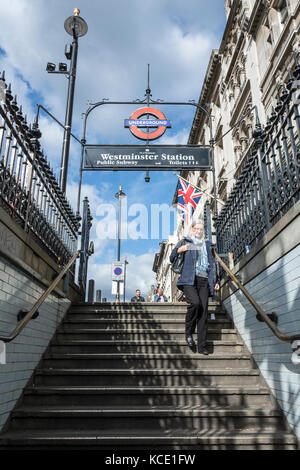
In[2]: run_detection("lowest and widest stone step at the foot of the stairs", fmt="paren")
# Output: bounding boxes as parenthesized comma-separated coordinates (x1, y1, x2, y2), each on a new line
(0, 429, 298, 450)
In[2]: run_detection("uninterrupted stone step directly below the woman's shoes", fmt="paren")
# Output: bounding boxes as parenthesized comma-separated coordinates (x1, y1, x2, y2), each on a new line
(43, 351, 253, 369)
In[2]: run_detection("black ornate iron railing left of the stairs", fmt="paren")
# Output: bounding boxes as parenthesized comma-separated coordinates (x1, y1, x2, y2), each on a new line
(0, 72, 79, 263)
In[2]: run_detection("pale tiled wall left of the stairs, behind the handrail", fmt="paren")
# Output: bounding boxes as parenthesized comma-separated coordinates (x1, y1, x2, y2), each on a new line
(0, 257, 70, 429)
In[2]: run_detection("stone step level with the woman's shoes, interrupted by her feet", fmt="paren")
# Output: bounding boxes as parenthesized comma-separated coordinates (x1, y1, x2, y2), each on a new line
(50, 338, 244, 354)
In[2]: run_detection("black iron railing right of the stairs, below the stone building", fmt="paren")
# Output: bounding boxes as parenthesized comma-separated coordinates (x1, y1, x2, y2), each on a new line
(214, 64, 300, 262)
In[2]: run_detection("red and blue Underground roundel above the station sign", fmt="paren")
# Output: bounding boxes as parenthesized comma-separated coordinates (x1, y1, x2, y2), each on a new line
(125, 107, 171, 140)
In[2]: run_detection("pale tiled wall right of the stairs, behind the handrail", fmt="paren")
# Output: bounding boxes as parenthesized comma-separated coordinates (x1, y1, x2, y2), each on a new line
(224, 246, 300, 439)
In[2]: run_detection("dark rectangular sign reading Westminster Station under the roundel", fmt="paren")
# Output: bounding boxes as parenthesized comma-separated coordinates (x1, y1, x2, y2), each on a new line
(84, 145, 211, 170)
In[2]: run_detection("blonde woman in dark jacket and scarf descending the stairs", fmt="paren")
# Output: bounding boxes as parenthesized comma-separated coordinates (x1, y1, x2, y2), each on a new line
(170, 220, 220, 355)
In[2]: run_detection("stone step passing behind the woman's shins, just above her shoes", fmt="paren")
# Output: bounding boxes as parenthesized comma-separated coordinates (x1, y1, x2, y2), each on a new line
(56, 325, 237, 342)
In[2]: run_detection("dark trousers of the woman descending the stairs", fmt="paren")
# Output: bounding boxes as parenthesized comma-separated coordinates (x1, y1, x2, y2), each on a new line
(183, 276, 209, 351)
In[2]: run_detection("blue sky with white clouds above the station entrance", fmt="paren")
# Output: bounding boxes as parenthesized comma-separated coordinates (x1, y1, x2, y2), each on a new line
(0, 0, 225, 299)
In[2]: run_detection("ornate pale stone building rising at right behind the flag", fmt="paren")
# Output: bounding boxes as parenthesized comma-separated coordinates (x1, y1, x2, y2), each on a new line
(155, 0, 300, 291)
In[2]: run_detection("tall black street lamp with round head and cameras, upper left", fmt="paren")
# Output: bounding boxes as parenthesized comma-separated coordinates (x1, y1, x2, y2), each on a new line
(46, 8, 88, 193)
